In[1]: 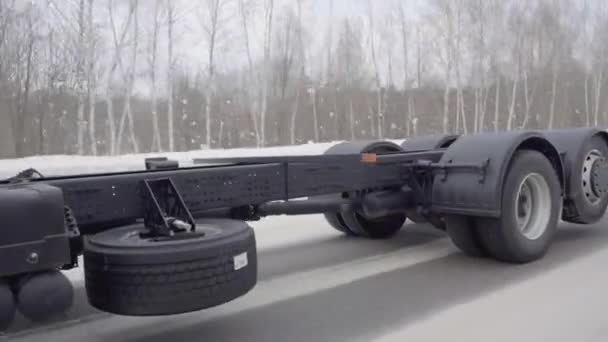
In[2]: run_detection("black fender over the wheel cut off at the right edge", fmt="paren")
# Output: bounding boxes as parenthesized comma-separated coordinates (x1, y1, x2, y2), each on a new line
(544, 127, 608, 199)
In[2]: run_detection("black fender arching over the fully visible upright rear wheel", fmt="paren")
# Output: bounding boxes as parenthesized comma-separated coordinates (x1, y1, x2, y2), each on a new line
(431, 131, 564, 217)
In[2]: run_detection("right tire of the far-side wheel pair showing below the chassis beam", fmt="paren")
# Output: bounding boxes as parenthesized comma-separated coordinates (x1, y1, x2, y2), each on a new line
(341, 211, 406, 239)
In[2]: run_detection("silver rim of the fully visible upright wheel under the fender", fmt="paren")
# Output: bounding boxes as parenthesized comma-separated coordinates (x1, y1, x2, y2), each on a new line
(515, 173, 552, 240)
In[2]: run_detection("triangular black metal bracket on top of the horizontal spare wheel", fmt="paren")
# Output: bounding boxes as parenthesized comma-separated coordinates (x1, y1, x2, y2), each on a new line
(142, 178, 196, 237)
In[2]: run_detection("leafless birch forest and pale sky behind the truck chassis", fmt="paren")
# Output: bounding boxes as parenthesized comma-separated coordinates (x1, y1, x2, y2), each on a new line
(0, 0, 608, 158)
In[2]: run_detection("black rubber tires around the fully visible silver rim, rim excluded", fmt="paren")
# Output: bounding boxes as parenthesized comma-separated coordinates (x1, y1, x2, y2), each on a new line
(475, 150, 561, 263)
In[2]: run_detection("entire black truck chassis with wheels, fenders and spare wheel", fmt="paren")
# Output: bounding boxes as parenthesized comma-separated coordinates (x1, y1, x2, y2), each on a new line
(0, 128, 608, 329)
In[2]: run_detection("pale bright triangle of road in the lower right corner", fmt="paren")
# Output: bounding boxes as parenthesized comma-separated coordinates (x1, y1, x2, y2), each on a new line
(376, 243, 608, 342)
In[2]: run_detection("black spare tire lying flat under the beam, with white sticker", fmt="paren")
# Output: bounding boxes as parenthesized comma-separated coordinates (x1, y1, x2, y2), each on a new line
(84, 219, 257, 316)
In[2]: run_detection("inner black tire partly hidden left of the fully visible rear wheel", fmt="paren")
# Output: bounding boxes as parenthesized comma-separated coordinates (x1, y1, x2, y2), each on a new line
(445, 215, 488, 258)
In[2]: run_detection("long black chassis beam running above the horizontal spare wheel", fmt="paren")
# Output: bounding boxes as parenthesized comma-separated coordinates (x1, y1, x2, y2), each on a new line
(0, 151, 436, 235)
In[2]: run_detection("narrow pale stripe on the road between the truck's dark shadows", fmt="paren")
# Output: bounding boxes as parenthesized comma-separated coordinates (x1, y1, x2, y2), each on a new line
(22, 239, 455, 342)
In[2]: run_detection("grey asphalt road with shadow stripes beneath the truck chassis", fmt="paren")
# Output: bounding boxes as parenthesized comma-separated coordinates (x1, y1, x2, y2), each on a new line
(4, 216, 608, 342)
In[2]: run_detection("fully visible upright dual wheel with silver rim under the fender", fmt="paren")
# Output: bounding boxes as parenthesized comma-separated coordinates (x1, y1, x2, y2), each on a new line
(476, 150, 561, 263)
